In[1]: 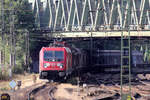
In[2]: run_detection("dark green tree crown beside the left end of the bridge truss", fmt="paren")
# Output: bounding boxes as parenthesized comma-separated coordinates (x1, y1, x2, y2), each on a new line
(15, 0, 35, 31)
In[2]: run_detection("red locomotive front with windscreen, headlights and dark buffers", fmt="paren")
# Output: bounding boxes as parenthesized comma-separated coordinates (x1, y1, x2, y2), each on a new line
(39, 47, 71, 79)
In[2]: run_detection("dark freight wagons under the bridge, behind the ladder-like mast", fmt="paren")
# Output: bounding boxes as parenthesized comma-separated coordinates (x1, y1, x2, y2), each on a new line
(92, 49, 150, 73)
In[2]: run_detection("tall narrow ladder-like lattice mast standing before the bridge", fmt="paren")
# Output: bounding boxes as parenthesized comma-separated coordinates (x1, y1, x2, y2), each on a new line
(121, 0, 131, 100)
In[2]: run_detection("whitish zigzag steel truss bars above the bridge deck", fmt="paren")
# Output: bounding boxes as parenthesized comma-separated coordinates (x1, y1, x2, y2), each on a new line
(29, 0, 150, 31)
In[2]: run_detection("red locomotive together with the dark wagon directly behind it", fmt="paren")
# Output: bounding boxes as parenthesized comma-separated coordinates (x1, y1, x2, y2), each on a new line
(39, 42, 87, 79)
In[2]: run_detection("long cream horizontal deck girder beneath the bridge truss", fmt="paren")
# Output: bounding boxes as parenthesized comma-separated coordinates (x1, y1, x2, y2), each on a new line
(52, 31, 150, 38)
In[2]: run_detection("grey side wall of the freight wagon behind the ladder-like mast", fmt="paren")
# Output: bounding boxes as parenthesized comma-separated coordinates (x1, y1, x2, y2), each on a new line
(94, 50, 148, 67)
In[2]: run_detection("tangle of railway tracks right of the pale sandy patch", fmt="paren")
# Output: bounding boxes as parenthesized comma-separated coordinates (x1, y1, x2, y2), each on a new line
(77, 73, 150, 100)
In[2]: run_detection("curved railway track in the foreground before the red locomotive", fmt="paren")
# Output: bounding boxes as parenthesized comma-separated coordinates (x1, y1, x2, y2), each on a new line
(28, 82, 58, 100)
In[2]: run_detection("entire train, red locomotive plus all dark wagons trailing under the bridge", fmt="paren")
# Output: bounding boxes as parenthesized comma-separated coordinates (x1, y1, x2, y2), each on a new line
(39, 42, 150, 79)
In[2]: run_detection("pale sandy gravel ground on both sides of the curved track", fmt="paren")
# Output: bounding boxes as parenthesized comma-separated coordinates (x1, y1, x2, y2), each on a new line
(0, 73, 150, 100)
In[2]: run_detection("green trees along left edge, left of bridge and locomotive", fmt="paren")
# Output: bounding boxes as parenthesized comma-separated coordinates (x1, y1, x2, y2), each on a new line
(0, 0, 35, 79)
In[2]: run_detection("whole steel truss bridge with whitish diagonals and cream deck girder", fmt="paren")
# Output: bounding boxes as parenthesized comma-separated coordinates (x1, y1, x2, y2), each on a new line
(29, 0, 150, 37)
